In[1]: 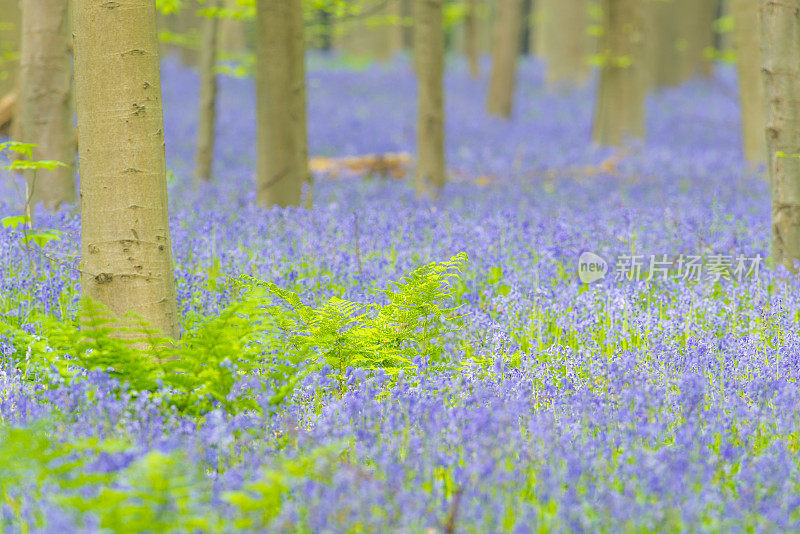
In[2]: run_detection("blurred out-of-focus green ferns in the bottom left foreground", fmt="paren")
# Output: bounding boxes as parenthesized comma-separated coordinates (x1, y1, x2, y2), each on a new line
(0, 421, 347, 533)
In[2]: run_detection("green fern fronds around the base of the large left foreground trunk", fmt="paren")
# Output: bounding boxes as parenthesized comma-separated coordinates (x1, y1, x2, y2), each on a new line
(0, 295, 304, 415)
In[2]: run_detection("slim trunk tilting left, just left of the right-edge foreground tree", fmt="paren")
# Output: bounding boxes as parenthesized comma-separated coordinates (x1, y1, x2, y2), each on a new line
(731, 0, 767, 163)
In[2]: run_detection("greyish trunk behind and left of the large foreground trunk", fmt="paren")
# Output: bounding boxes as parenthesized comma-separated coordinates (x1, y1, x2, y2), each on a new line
(19, 0, 75, 210)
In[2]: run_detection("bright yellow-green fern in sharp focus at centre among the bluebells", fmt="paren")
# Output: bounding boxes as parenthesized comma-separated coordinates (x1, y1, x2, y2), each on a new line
(241, 253, 467, 386)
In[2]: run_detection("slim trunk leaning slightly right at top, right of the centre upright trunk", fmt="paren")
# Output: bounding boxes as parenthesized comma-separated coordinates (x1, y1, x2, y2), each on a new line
(486, 0, 522, 117)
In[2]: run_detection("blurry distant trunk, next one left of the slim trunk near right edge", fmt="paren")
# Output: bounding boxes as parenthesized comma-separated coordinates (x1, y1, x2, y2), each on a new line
(674, 0, 717, 81)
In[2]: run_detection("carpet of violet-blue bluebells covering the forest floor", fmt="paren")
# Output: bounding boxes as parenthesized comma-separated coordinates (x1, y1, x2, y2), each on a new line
(0, 53, 800, 533)
